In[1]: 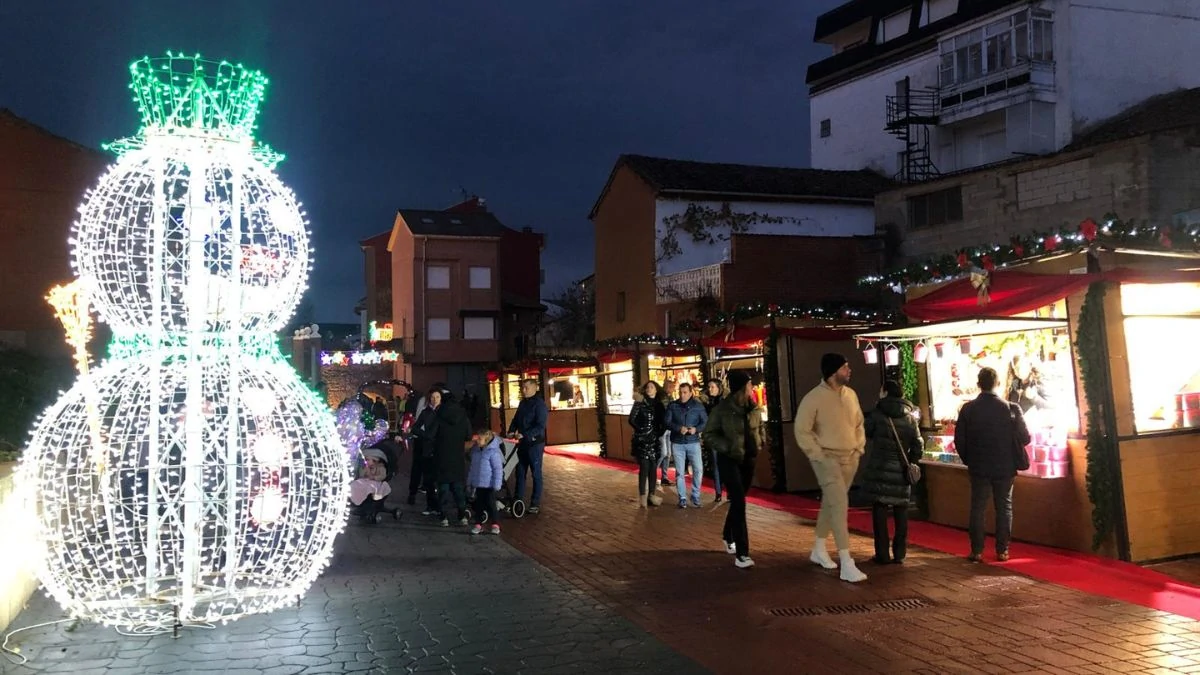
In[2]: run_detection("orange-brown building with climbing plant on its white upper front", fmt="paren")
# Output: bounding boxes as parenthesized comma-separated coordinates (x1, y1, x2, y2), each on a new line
(590, 155, 894, 340)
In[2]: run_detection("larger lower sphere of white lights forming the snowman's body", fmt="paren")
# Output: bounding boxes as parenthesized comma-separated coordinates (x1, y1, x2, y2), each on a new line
(22, 348, 348, 628)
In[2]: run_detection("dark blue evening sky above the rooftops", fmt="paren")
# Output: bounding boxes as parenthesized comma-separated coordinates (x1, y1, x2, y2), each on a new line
(0, 0, 840, 321)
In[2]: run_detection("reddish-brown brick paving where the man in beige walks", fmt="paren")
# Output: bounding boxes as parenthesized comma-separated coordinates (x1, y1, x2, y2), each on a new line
(505, 456, 1200, 675)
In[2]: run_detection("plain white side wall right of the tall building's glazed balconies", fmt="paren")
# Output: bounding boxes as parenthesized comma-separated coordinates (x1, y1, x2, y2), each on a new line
(1075, 0, 1200, 131)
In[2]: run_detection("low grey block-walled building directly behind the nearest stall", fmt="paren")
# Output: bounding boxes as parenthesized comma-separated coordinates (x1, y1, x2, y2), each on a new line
(875, 89, 1200, 258)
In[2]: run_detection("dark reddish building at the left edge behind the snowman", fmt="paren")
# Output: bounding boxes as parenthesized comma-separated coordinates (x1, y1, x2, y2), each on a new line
(0, 108, 109, 353)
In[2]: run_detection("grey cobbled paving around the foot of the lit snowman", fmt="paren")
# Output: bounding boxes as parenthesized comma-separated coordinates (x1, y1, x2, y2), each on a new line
(0, 492, 704, 675)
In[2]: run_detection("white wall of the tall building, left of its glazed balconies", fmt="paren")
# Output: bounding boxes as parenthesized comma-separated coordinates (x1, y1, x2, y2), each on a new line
(809, 49, 938, 175)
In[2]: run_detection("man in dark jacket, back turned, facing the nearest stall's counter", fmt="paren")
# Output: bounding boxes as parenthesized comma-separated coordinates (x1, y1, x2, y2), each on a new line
(954, 368, 1030, 562)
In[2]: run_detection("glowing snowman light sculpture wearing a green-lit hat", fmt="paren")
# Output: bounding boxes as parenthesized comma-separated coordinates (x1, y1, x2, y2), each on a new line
(22, 53, 348, 631)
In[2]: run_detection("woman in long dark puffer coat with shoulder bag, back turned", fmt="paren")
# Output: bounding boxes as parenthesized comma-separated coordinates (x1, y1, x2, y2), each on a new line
(863, 380, 924, 565)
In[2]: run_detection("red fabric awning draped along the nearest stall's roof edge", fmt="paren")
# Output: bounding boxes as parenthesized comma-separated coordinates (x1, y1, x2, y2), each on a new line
(904, 268, 1200, 321)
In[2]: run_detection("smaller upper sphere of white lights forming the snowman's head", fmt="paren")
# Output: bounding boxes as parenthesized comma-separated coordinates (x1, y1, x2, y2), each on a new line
(72, 139, 308, 333)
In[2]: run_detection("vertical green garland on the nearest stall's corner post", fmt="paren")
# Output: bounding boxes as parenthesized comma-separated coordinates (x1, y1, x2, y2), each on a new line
(1075, 282, 1117, 550)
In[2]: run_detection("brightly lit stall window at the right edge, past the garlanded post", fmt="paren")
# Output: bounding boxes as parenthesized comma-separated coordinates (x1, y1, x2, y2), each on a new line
(1121, 283, 1200, 434)
